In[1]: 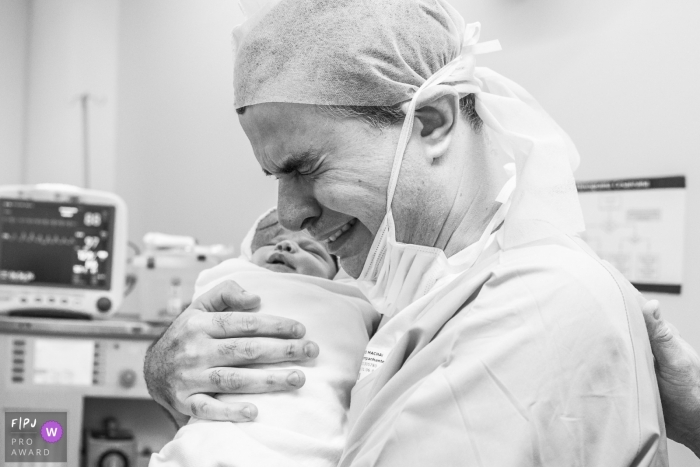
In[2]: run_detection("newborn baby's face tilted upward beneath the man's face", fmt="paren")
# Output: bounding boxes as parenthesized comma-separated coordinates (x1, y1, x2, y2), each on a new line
(253, 231, 338, 279)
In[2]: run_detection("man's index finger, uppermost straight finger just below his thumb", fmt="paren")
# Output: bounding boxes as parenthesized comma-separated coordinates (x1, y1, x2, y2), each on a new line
(198, 311, 306, 339)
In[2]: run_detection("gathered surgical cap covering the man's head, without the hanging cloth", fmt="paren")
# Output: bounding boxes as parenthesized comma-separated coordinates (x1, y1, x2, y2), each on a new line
(233, 0, 464, 108)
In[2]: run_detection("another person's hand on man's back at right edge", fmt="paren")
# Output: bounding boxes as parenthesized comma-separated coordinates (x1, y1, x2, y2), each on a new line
(642, 300, 700, 457)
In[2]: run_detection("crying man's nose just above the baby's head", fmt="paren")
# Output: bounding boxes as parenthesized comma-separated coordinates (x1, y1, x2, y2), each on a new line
(277, 177, 321, 232)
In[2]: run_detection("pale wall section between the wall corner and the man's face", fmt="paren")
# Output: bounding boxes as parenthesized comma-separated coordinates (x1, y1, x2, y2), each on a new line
(117, 0, 276, 247)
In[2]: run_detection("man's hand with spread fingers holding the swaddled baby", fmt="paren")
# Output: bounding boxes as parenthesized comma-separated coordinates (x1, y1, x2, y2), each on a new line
(144, 281, 318, 422)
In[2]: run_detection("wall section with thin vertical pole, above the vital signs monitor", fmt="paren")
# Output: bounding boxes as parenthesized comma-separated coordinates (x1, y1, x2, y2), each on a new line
(25, 0, 119, 190)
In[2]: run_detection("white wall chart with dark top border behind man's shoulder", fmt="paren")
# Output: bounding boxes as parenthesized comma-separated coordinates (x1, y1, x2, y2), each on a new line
(577, 177, 685, 294)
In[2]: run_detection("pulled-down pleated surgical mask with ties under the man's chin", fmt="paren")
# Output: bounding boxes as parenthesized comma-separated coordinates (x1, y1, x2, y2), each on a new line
(357, 26, 504, 317)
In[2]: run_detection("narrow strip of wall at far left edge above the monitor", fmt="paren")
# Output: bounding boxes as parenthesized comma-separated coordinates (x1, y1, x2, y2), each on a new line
(0, 0, 29, 185)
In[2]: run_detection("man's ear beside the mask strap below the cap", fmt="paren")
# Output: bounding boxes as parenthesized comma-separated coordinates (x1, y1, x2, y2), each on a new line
(403, 85, 460, 160)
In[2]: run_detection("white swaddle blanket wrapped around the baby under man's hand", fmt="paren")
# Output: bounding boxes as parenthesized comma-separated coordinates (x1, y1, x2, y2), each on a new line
(149, 259, 378, 467)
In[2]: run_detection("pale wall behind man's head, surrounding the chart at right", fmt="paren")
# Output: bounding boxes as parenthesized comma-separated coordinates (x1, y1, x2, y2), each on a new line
(451, 0, 700, 467)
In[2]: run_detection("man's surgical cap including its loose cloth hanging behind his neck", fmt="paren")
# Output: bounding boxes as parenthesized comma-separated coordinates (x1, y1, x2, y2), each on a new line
(233, 0, 584, 247)
